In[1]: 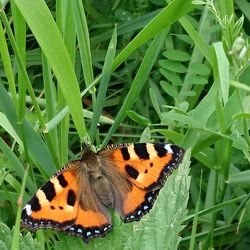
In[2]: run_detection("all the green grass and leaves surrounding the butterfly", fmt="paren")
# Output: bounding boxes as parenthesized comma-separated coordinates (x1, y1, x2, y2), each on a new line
(0, 0, 250, 250)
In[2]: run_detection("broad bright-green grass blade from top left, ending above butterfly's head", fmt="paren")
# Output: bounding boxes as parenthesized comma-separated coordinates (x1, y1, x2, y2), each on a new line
(14, 0, 87, 138)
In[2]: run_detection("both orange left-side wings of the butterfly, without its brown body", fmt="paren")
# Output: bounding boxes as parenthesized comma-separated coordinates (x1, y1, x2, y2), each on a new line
(21, 161, 111, 242)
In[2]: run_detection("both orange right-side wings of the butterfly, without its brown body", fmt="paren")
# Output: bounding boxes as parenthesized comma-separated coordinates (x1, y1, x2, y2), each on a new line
(98, 143, 185, 222)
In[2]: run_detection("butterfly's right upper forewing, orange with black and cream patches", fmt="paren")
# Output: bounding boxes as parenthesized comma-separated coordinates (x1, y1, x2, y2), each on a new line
(99, 143, 184, 190)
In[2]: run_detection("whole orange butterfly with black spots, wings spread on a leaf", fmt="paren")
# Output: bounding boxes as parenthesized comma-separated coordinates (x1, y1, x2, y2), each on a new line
(21, 143, 185, 242)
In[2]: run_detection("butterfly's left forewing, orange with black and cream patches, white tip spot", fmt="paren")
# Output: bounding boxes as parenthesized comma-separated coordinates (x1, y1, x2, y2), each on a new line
(22, 161, 79, 230)
